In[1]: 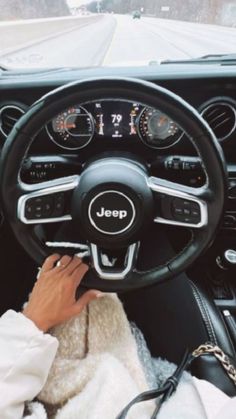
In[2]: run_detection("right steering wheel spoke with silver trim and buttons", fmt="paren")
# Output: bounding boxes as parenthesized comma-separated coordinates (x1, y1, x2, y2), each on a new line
(148, 177, 208, 229)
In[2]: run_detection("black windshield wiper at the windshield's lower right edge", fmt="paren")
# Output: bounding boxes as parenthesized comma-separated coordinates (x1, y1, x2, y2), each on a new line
(160, 54, 236, 65)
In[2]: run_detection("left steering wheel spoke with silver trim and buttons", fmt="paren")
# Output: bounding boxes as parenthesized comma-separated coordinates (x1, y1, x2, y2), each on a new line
(17, 176, 80, 224)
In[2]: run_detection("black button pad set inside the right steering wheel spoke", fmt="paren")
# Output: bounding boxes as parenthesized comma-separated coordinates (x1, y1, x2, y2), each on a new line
(172, 198, 201, 224)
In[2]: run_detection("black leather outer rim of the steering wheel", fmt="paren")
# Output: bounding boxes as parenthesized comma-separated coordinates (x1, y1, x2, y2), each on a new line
(0, 77, 227, 291)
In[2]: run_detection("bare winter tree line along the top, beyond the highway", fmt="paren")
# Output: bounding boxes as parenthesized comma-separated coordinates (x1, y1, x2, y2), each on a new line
(0, 0, 236, 26)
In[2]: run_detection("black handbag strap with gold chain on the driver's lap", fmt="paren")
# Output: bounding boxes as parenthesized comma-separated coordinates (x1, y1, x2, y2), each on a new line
(116, 343, 236, 419)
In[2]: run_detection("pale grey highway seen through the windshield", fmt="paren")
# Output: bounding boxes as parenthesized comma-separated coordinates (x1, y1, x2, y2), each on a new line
(0, 15, 236, 68)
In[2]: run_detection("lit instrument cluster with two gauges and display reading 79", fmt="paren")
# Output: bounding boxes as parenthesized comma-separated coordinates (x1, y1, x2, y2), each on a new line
(46, 100, 183, 150)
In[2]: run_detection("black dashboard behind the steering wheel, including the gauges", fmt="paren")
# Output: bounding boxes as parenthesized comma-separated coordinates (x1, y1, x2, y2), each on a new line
(0, 65, 236, 229)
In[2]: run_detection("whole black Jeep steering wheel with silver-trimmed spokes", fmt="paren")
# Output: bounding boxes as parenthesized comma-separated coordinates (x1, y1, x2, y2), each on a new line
(0, 78, 227, 291)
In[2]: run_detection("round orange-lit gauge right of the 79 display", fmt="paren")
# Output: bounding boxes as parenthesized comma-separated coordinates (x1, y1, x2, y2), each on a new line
(138, 108, 183, 148)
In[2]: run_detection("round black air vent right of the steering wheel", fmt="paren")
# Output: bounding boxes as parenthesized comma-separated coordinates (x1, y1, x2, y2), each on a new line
(202, 102, 236, 141)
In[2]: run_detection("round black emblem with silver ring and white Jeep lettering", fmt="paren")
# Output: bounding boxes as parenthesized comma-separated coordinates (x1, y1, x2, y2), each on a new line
(88, 190, 136, 235)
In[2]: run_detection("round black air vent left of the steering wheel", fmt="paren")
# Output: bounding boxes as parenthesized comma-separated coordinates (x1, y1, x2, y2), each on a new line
(0, 105, 25, 137)
